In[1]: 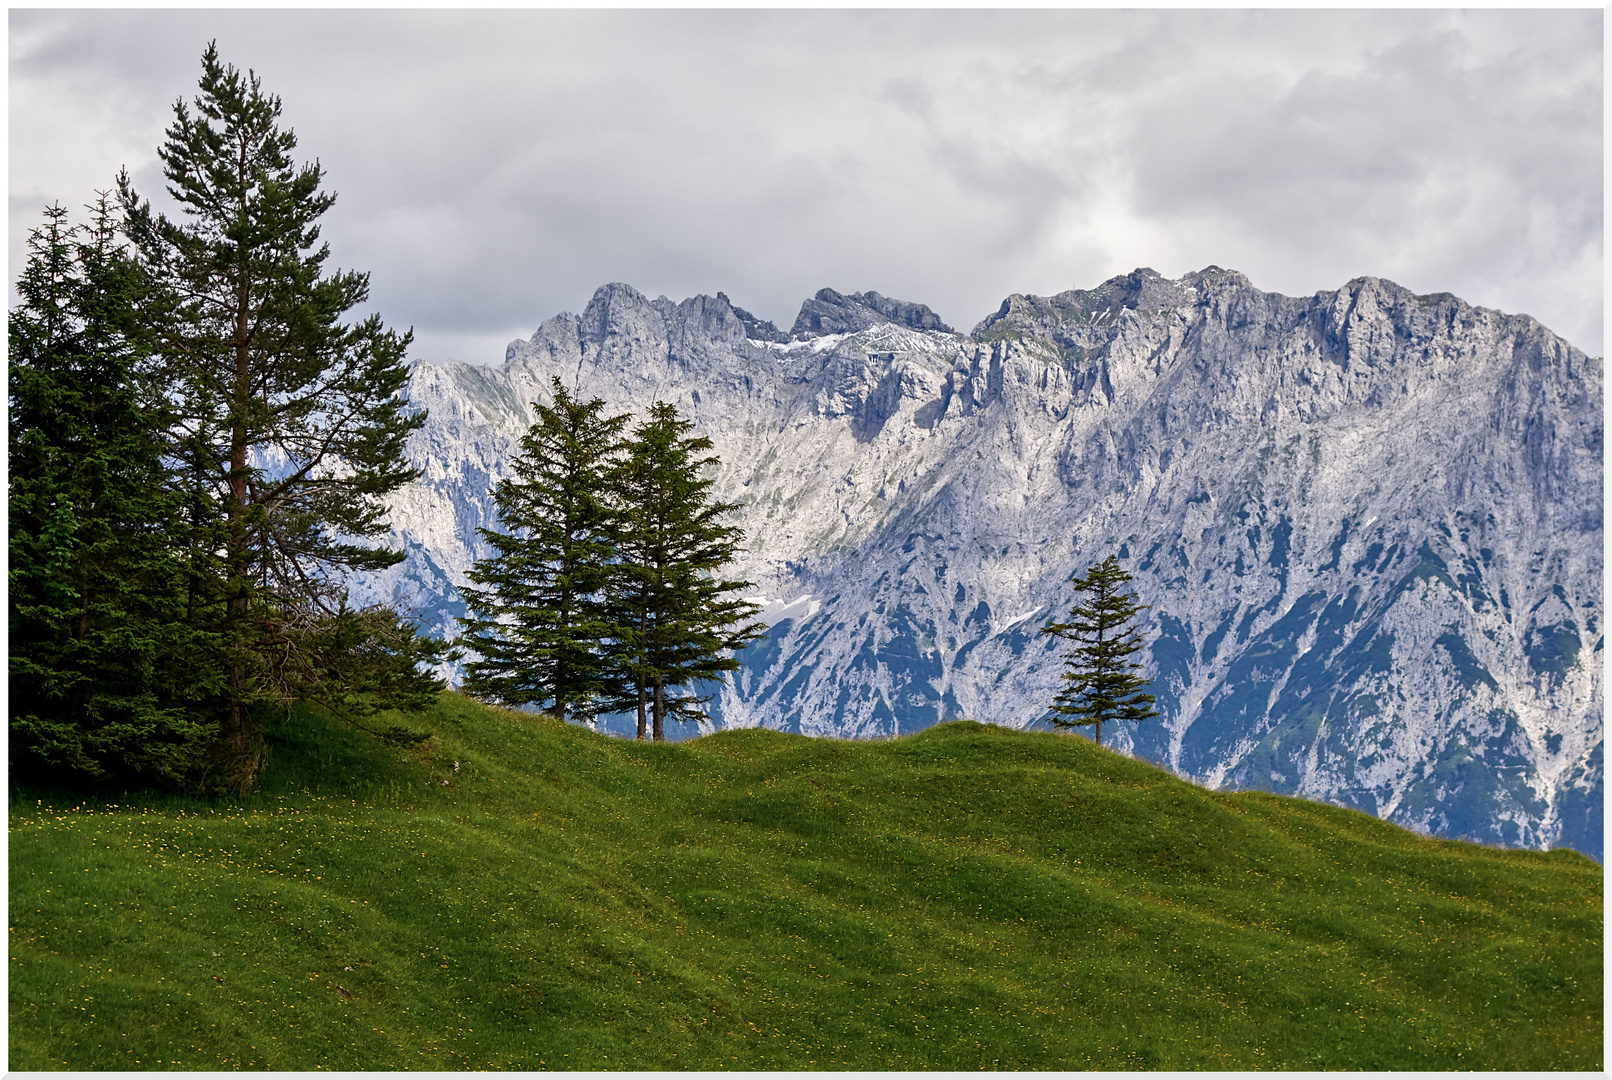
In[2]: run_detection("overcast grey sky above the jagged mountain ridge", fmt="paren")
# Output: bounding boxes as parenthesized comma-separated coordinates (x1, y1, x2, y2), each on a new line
(8, 8, 1604, 363)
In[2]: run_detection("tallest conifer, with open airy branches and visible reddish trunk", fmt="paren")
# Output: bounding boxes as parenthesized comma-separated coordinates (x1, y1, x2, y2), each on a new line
(119, 45, 442, 790)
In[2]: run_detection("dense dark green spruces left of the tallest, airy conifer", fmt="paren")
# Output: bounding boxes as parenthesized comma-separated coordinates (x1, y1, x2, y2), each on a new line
(6, 197, 222, 783)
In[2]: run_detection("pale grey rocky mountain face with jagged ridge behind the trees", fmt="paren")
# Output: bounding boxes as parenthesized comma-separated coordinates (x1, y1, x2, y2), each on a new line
(356, 268, 1604, 859)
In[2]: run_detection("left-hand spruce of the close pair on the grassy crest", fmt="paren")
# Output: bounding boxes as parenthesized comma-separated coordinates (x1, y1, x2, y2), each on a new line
(461, 377, 627, 721)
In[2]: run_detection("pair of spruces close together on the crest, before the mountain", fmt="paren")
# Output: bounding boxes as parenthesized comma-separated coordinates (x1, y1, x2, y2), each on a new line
(461, 385, 764, 741)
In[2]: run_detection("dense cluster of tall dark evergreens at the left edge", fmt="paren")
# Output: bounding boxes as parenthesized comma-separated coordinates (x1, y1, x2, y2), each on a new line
(8, 47, 447, 790)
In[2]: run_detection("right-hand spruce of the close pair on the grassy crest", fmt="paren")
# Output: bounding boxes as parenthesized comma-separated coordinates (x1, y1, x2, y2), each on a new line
(609, 401, 766, 741)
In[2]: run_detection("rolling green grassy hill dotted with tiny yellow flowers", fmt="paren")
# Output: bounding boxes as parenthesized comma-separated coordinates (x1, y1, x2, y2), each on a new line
(8, 695, 1602, 1070)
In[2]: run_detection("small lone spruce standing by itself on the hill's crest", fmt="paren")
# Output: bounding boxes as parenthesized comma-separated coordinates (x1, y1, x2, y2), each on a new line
(1041, 555, 1159, 745)
